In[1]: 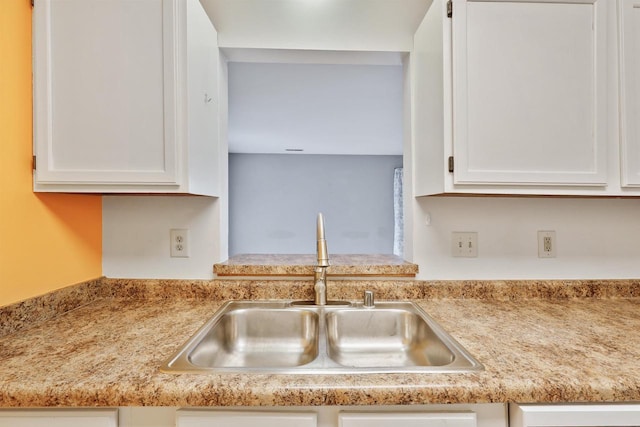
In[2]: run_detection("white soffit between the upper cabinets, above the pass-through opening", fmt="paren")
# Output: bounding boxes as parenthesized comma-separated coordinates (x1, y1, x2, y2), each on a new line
(200, 0, 431, 52)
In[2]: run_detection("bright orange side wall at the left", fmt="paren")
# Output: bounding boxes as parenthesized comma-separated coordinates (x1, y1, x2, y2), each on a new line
(0, 0, 102, 306)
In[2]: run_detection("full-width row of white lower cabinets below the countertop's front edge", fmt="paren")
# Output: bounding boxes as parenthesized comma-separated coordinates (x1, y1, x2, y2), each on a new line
(10, 403, 640, 427)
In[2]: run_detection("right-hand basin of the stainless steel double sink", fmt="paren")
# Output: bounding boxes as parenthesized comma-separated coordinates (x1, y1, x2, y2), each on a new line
(327, 308, 456, 368)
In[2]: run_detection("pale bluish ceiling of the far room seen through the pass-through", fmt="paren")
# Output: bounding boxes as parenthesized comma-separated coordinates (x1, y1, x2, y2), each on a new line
(229, 62, 402, 155)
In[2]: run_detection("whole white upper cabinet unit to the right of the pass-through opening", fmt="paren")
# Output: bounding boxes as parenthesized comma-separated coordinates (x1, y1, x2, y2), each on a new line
(409, 0, 640, 196)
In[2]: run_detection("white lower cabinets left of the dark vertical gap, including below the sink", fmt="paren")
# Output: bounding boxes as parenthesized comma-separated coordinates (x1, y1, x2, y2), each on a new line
(0, 403, 504, 427)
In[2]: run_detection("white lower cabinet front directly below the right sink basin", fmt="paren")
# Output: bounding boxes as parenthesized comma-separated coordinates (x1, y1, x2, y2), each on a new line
(338, 412, 476, 427)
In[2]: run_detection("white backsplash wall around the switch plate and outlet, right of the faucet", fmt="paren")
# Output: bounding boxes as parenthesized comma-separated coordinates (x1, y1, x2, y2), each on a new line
(412, 197, 640, 279)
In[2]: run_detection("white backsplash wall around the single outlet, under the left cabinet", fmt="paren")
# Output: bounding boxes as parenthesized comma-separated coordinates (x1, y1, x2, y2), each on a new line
(102, 196, 226, 279)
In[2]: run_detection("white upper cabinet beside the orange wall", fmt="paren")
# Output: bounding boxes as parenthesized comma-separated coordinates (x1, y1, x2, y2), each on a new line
(34, 0, 219, 195)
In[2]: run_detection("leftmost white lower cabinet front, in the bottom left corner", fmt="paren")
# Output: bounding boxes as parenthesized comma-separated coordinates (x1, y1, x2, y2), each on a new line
(0, 409, 118, 427)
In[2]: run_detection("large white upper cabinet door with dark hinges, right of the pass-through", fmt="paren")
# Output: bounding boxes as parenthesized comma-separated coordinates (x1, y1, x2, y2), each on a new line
(452, 0, 609, 186)
